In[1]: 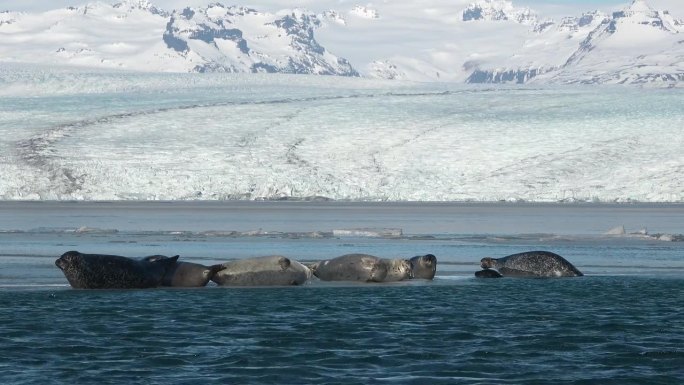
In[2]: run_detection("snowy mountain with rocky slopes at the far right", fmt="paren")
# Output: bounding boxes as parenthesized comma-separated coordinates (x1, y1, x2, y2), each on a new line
(468, 0, 684, 85)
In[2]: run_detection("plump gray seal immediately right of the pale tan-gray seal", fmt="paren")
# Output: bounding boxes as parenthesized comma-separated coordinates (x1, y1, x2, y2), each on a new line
(311, 254, 388, 282)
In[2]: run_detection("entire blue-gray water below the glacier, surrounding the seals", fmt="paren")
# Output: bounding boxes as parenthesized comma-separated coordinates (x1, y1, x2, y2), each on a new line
(0, 202, 684, 385)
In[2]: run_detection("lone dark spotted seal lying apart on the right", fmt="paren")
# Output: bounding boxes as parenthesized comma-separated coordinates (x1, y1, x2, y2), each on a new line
(480, 251, 584, 277)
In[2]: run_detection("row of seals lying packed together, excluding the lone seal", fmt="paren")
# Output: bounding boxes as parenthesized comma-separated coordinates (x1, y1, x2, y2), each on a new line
(55, 251, 437, 289)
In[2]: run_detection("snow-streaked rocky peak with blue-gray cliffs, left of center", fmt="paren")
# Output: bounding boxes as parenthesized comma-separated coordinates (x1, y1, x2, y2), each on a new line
(163, 3, 358, 76)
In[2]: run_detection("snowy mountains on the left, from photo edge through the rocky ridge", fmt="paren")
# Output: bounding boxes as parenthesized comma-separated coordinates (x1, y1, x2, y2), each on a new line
(0, 0, 358, 76)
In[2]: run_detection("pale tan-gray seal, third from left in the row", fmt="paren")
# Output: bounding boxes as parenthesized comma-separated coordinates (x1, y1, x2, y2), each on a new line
(211, 255, 311, 286)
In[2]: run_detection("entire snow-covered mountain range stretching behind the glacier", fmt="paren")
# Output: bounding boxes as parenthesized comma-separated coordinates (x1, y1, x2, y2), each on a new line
(0, 0, 684, 86)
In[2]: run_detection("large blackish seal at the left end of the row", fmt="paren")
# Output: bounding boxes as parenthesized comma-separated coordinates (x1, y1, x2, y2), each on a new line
(55, 251, 178, 289)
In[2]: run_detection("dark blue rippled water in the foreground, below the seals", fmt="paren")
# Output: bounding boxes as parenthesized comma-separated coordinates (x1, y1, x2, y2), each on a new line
(0, 276, 684, 384)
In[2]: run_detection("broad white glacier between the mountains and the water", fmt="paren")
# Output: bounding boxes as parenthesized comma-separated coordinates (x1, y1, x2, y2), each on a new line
(0, 63, 684, 202)
